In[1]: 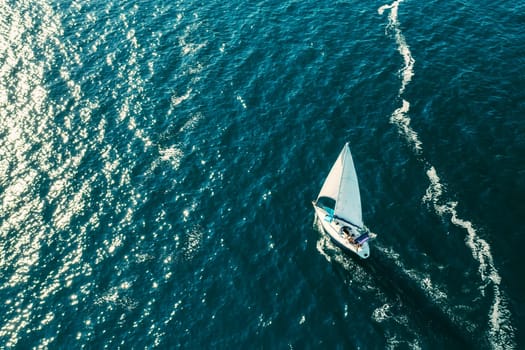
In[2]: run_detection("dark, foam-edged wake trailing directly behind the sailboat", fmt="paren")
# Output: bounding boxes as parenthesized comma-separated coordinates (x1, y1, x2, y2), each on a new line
(314, 217, 472, 349)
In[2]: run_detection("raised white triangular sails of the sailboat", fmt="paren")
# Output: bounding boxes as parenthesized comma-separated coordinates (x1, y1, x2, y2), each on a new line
(318, 143, 363, 227)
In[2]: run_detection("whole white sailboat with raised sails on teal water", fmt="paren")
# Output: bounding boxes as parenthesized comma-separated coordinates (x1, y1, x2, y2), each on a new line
(312, 142, 375, 259)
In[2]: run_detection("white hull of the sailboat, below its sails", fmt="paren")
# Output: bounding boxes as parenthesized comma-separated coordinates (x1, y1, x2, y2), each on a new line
(314, 203, 370, 259)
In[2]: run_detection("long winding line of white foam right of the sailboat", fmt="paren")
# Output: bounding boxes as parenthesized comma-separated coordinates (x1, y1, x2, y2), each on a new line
(378, 0, 515, 348)
